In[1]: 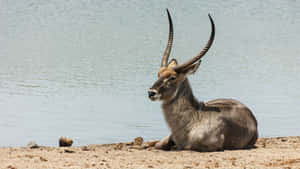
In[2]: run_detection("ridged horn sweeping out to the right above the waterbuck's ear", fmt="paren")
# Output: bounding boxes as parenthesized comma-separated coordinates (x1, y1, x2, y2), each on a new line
(173, 14, 215, 71)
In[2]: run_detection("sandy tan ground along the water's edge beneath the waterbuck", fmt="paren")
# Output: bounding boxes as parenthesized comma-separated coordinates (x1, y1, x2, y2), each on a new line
(0, 136, 300, 169)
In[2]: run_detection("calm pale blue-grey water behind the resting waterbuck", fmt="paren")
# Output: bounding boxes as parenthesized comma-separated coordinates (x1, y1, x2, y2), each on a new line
(0, 0, 300, 146)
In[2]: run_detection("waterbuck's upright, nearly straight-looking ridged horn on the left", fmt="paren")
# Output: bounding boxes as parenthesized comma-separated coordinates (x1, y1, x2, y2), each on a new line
(161, 9, 173, 67)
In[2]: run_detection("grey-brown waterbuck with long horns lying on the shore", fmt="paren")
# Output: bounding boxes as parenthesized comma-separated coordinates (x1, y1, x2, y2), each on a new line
(148, 9, 258, 151)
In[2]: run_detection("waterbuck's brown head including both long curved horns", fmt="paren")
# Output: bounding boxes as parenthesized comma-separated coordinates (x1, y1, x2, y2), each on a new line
(148, 9, 215, 100)
